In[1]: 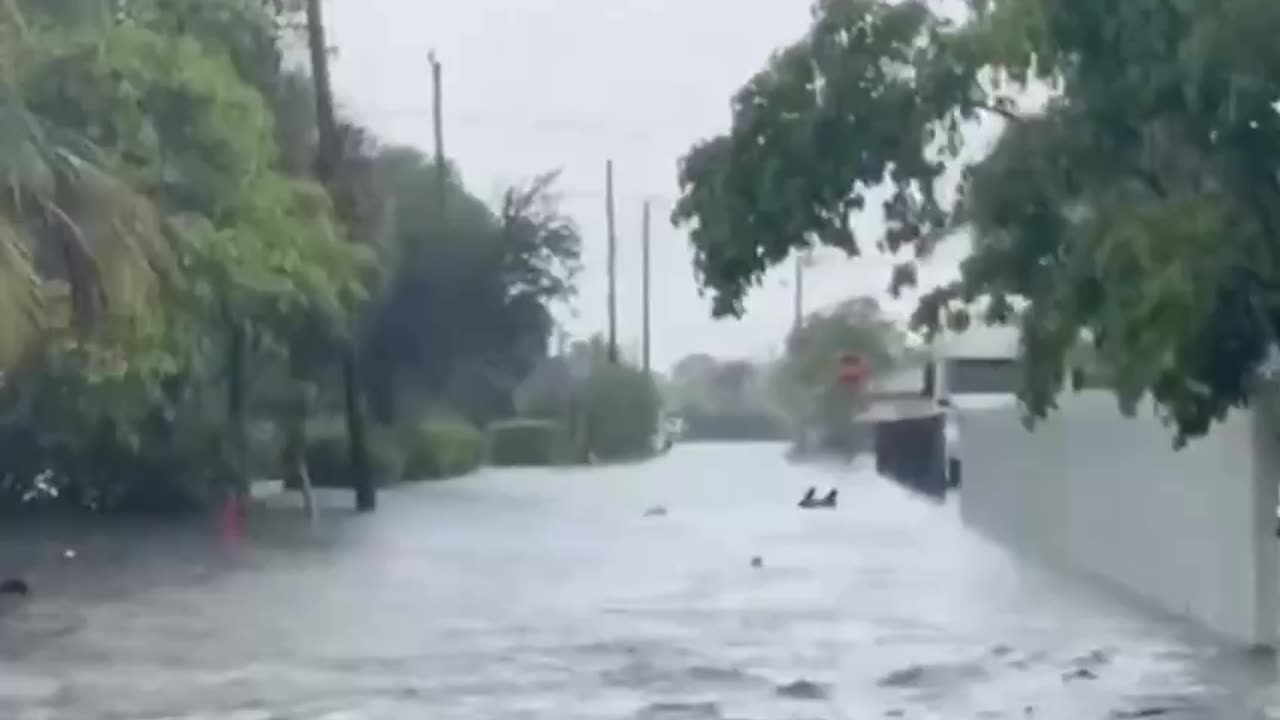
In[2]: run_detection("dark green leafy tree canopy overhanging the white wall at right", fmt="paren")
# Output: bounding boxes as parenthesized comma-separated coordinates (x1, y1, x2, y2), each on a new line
(673, 0, 1280, 443)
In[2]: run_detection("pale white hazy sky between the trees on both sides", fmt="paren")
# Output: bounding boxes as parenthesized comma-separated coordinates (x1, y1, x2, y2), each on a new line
(326, 0, 983, 368)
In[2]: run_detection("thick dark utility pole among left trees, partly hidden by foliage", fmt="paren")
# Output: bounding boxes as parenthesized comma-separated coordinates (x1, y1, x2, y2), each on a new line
(306, 0, 378, 512)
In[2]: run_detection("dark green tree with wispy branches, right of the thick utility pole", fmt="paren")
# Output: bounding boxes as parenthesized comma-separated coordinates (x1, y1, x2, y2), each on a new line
(364, 147, 581, 424)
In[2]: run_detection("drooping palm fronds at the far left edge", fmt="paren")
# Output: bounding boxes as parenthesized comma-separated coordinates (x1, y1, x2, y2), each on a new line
(0, 9, 168, 369)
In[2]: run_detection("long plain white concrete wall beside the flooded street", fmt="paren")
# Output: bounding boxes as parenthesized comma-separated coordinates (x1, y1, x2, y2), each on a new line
(957, 391, 1280, 644)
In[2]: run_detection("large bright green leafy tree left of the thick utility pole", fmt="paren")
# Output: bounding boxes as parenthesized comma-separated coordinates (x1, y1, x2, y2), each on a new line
(0, 3, 370, 506)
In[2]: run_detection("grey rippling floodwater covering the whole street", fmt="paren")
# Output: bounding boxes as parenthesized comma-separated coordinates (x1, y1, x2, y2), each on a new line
(0, 445, 1280, 720)
